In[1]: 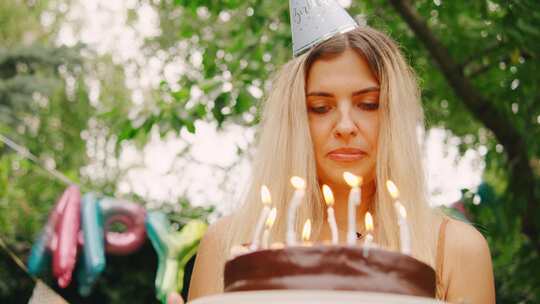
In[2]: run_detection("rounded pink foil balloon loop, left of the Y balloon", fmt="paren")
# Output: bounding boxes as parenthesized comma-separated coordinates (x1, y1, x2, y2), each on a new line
(99, 198, 146, 255)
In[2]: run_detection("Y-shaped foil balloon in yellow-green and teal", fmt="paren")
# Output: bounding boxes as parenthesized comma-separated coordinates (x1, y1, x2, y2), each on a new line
(146, 212, 206, 303)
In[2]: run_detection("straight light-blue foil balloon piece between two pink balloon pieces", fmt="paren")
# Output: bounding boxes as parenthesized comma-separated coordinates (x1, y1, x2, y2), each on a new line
(77, 193, 105, 296)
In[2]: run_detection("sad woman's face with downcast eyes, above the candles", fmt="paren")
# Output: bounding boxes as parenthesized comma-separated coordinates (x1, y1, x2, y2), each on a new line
(306, 48, 379, 186)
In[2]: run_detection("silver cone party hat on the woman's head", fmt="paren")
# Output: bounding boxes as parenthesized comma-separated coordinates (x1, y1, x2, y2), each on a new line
(289, 0, 358, 57)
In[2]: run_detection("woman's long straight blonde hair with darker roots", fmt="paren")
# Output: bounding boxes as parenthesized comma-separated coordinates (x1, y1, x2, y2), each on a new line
(225, 27, 437, 280)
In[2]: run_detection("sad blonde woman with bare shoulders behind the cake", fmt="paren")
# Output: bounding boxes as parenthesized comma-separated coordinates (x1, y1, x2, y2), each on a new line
(185, 27, 495, 303)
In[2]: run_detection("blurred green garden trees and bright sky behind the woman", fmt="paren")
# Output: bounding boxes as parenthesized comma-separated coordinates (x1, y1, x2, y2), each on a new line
(0, 0, 540, 303)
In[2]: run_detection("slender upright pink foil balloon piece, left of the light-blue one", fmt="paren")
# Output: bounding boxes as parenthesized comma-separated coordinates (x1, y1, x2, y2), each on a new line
(49, 186, 81, 288)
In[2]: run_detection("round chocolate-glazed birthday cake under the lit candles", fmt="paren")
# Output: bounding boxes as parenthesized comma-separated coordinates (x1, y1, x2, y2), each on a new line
(224, 245, 436, 298)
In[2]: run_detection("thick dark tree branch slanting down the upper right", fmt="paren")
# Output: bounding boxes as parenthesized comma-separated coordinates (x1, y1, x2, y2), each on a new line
(389, 0, 540, 254)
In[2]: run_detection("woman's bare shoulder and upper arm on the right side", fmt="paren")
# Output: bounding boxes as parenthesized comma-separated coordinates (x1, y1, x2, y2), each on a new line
(444, 220, 495, 303)
